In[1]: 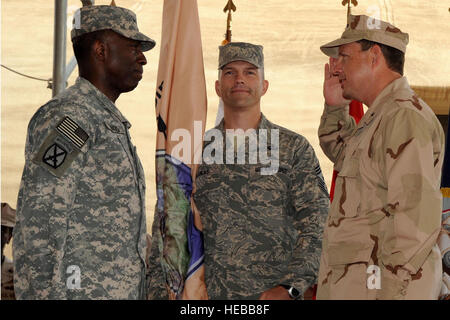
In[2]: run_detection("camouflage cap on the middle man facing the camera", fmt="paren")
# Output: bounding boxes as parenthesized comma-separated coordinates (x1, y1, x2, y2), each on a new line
(219, 42, 264, 69)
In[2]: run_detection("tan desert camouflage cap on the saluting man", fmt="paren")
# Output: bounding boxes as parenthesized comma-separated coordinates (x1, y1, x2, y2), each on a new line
(320, 15, 409, 58)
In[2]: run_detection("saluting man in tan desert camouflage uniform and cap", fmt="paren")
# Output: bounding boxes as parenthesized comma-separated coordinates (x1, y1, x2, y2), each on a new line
(317, 15, 444, 299)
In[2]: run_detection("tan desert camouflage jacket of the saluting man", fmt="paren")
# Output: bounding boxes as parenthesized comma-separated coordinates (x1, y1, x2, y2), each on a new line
(317, 78, 444, 299)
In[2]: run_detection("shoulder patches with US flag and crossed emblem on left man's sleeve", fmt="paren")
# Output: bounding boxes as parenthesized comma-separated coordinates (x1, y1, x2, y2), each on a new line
(33, 117, 89, 177)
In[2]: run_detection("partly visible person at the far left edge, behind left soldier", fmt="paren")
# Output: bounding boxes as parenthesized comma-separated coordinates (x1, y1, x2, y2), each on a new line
(1, 202, 16, 300)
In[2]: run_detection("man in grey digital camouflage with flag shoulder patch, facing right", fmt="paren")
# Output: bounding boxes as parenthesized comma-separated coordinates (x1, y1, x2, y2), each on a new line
(13, 6, 155, 299)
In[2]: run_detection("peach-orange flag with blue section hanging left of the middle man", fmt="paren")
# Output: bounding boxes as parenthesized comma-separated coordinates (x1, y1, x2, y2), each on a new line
(153, 0, 207, 299)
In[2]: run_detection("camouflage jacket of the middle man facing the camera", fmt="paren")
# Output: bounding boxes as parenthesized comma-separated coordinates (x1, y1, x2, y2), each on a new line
(194, 115, 329, 299)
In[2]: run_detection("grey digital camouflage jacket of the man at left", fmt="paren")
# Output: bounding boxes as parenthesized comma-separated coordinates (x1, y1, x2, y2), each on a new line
(13, 77, 146, 299)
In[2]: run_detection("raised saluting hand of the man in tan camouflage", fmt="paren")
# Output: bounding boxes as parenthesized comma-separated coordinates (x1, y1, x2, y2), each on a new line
(323, 57, 350, 106)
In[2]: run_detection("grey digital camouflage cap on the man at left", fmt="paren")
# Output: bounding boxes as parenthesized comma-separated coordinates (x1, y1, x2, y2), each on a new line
(70, 5, 155, 51)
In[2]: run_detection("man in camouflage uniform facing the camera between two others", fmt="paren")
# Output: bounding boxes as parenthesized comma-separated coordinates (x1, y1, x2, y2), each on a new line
(150, 42, 329, 299)
